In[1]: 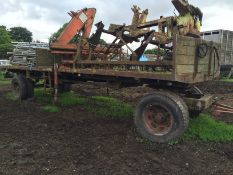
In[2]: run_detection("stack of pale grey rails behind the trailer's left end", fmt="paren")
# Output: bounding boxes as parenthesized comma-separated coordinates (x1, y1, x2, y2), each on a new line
(8, 42, 49, 67)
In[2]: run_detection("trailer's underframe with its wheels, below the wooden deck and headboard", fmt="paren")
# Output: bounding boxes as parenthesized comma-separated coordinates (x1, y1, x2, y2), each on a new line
(3, 64, 221, 143)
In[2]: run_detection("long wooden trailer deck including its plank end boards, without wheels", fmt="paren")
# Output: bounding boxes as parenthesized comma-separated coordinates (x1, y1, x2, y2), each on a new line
(5, 35, 220, 84)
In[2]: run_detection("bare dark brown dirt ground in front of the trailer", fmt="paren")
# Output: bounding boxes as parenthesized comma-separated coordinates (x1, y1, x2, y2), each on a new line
(0, 82, 233, 175)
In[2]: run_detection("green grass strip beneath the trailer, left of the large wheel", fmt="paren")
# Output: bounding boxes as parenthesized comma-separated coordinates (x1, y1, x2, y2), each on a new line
(35, 89, 133, 118)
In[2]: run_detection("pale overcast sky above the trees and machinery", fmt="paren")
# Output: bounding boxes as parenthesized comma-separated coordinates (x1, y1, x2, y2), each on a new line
(0, 0, 233, 41)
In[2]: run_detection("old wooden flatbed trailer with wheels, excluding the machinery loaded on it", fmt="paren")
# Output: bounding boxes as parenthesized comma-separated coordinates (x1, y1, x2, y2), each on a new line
(2, 35, 225, 142)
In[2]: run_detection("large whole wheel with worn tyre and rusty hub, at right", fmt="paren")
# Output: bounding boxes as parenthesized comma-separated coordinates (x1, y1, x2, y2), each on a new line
(134, 92, 189, 143)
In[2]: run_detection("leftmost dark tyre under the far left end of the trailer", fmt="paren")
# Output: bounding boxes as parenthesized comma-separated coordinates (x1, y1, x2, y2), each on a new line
(11, 74, 27, 100)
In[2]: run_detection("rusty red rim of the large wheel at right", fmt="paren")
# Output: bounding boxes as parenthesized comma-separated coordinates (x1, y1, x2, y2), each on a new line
(143, 104, 174, 136)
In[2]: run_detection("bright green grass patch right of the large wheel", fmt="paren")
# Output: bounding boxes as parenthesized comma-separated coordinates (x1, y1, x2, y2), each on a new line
(183, 114, 233, 142)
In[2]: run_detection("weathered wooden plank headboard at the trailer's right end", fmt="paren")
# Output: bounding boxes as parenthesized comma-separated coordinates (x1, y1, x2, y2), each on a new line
(173, 36, 220, 83)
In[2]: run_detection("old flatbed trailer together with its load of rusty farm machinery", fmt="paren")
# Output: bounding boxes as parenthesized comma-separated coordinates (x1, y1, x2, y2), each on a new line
(3, 0, 233, 142)
